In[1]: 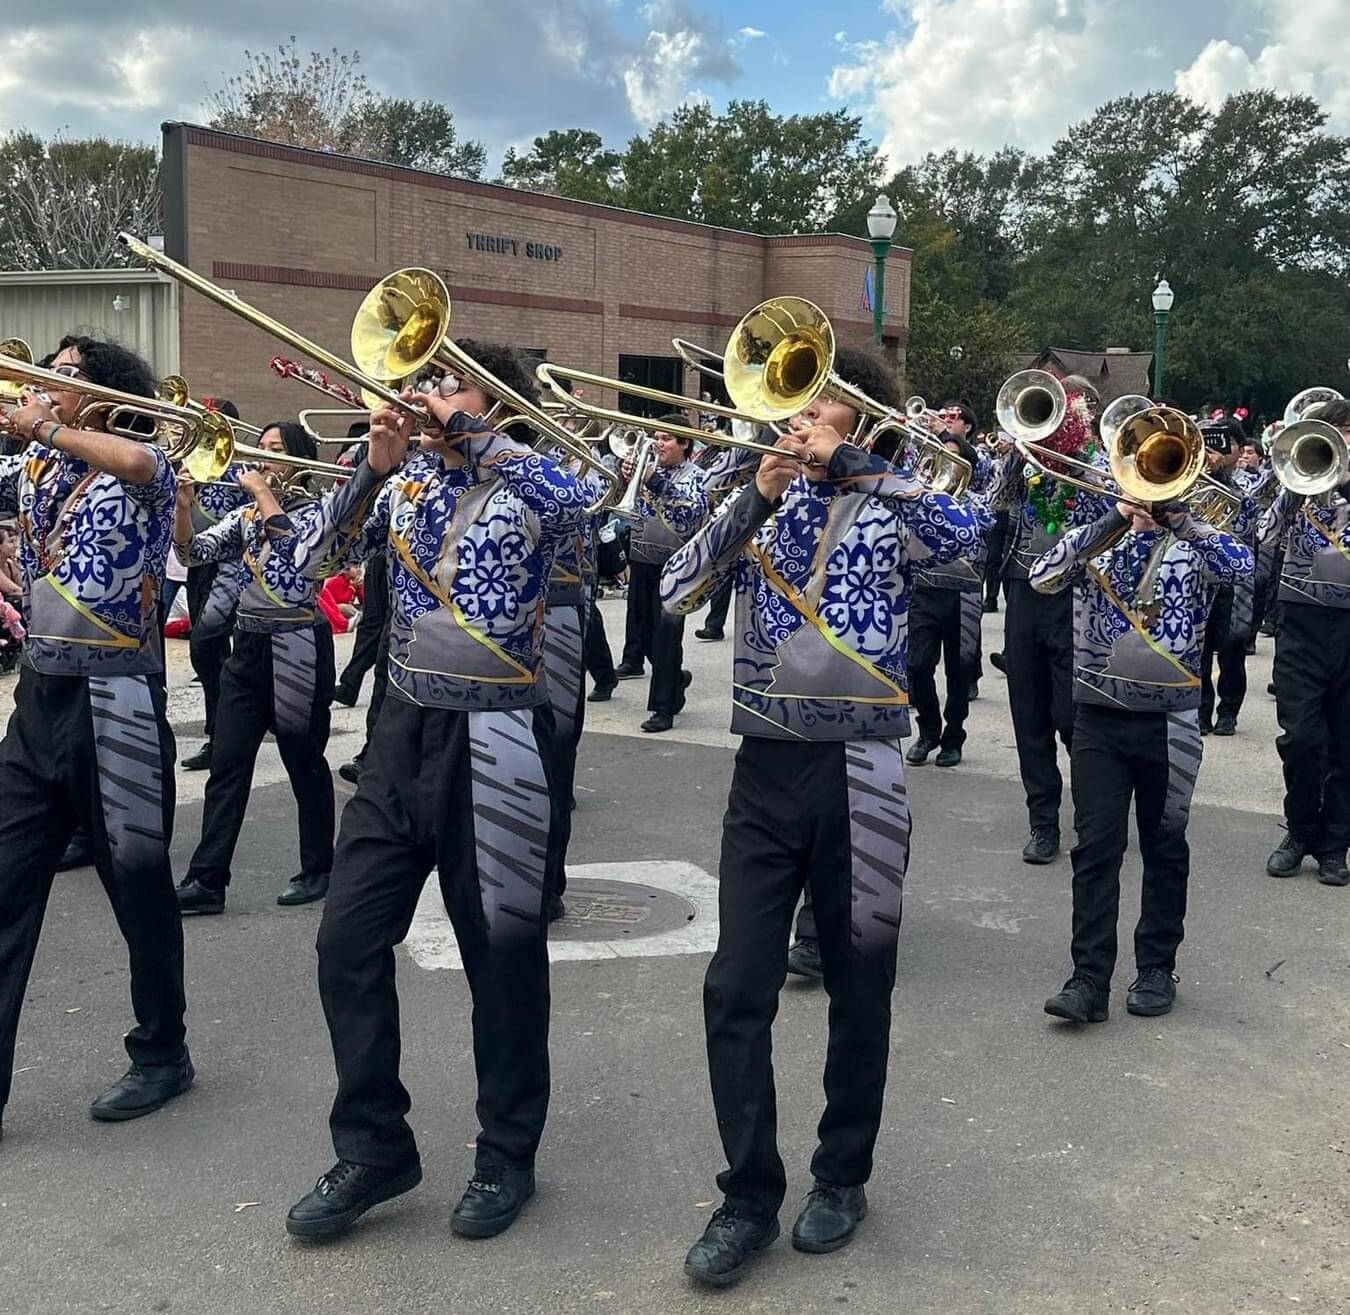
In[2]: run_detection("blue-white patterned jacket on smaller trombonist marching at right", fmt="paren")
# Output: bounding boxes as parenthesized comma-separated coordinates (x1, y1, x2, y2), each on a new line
(1030, 508, 1256, 713)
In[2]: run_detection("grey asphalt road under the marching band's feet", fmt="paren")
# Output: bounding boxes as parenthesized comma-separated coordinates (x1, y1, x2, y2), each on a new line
(0, 603, 1350, 1315)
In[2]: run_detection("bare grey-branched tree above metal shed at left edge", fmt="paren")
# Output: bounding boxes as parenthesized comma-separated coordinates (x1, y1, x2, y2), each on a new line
(0, 130, 163, 270)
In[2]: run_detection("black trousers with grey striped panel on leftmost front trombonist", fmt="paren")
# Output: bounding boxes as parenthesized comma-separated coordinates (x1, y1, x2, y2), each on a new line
(0, 667, 186, 1107)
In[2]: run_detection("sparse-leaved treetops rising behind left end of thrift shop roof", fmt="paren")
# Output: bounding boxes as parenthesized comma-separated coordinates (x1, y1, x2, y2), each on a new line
(207, 36, 487, 178)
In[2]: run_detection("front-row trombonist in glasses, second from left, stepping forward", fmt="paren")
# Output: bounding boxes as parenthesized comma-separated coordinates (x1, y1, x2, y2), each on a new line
(286, 342, 586, 1237)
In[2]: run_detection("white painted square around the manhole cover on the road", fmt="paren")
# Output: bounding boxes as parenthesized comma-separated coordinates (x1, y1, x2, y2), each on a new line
(404, 860, 717, 969)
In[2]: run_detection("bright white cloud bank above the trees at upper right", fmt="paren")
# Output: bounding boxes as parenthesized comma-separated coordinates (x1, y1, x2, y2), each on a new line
(829, 0, 1350, 166)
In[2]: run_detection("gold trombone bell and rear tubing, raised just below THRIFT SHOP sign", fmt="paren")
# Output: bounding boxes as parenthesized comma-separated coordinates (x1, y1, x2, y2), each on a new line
(348, 267, 622, 510)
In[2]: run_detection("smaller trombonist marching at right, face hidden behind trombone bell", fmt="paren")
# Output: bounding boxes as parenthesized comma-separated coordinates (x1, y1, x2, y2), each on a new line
(1030, 502, 1254, 1023)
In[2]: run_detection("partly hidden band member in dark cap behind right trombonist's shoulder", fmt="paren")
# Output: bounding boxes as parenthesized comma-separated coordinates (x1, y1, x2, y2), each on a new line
(1200, 417, 1260, 736)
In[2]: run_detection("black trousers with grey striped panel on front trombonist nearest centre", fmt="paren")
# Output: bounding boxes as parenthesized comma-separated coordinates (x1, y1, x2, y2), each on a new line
(703, 736, 910, 1219)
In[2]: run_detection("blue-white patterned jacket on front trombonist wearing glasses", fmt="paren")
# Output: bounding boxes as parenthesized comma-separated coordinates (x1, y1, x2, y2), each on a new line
(296, 414, 591, 710)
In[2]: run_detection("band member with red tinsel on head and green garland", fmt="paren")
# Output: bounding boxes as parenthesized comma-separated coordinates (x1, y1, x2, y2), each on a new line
(990, 374, 1103, 863)
